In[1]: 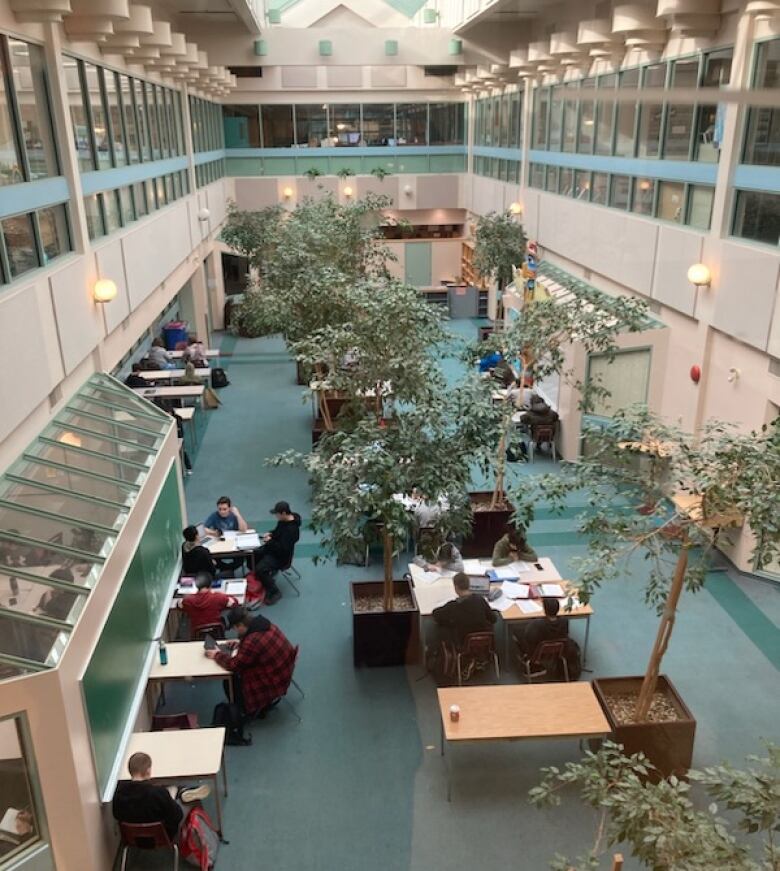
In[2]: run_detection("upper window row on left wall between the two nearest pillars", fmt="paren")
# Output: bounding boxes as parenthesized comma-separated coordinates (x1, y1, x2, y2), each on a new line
(63, 56, 185, 171)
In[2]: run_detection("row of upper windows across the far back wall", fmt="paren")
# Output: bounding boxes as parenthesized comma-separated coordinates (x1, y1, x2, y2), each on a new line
(222, 103, 466, 148)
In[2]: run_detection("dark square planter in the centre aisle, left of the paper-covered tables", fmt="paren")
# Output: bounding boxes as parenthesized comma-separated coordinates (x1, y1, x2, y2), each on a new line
(350, 581, 420, 667)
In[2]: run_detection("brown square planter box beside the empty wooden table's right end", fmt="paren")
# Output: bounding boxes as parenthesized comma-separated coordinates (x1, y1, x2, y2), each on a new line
(593, 675, 696, 777)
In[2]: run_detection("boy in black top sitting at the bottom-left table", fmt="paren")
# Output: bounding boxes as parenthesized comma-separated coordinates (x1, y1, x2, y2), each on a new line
(111, 753, 211, 841)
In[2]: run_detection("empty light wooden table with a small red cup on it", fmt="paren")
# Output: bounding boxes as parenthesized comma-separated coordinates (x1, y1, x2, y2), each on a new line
(438, 683, 611, 801)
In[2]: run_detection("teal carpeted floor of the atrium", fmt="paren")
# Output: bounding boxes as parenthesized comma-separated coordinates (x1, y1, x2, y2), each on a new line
(132, 321, 780, 871)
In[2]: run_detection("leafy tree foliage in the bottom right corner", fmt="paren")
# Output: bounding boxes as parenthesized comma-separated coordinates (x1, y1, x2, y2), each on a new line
(529, 742, 780, 871)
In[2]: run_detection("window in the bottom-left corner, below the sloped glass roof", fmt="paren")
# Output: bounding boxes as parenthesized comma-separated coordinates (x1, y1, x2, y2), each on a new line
(0, 716, 46, 865)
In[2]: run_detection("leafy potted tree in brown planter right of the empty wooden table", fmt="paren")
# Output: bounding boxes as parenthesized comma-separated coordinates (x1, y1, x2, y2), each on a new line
(513, 407, 780, 776)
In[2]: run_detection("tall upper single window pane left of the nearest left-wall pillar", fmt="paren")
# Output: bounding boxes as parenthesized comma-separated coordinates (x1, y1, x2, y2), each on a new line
(7, 39, 59, 184)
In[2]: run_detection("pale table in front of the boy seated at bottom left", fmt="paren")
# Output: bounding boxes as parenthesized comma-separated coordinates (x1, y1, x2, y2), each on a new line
(119, 728, 227, 838)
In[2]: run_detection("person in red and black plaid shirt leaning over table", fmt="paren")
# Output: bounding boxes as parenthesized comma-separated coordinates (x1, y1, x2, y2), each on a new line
(206, 608, 295, 716)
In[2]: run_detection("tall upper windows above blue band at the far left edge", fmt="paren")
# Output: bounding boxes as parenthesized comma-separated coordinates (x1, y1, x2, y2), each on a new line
(0, 35, 60, 185)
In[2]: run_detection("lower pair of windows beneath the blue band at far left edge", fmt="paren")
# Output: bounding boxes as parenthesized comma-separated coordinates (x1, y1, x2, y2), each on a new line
(0, 204, 72, 283)
